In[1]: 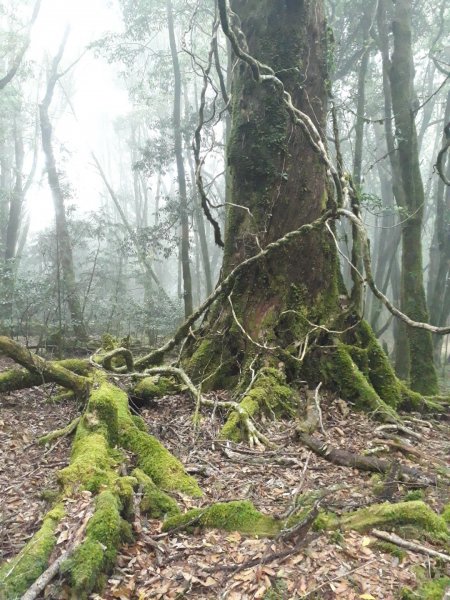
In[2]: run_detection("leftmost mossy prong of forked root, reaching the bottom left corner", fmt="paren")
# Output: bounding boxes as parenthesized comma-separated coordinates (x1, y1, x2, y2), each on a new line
(0, 505, 64, 599)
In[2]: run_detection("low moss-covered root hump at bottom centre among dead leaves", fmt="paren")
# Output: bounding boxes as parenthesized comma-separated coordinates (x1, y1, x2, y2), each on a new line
(163, 500, 282, 537)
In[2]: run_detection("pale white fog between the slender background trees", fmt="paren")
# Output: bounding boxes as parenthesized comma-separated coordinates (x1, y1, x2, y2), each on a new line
(1, 0, 449, 360)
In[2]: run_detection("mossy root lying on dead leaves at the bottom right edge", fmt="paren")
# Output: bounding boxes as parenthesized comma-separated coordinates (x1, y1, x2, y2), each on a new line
(316, 500, 450, 541)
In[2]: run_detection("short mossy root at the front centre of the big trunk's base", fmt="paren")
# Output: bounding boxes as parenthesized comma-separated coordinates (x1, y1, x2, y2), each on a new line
(220, 367, 296, 442)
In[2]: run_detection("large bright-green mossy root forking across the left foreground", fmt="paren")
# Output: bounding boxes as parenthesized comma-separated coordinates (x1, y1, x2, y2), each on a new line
(0, 372, 201, 599)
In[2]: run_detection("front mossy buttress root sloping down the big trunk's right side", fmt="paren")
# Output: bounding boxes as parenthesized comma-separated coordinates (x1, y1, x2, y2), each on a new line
(325, 343, 399, 423)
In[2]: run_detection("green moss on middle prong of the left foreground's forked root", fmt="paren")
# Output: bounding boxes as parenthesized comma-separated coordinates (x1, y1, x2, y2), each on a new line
(61, 491, 124, 599)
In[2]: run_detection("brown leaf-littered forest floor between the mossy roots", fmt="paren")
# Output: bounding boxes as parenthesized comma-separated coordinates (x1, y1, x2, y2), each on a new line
(0, 359, 450, 600)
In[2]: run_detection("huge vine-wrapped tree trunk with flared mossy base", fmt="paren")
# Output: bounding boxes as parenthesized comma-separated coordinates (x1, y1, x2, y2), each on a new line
(184, 0, 418, 439)
